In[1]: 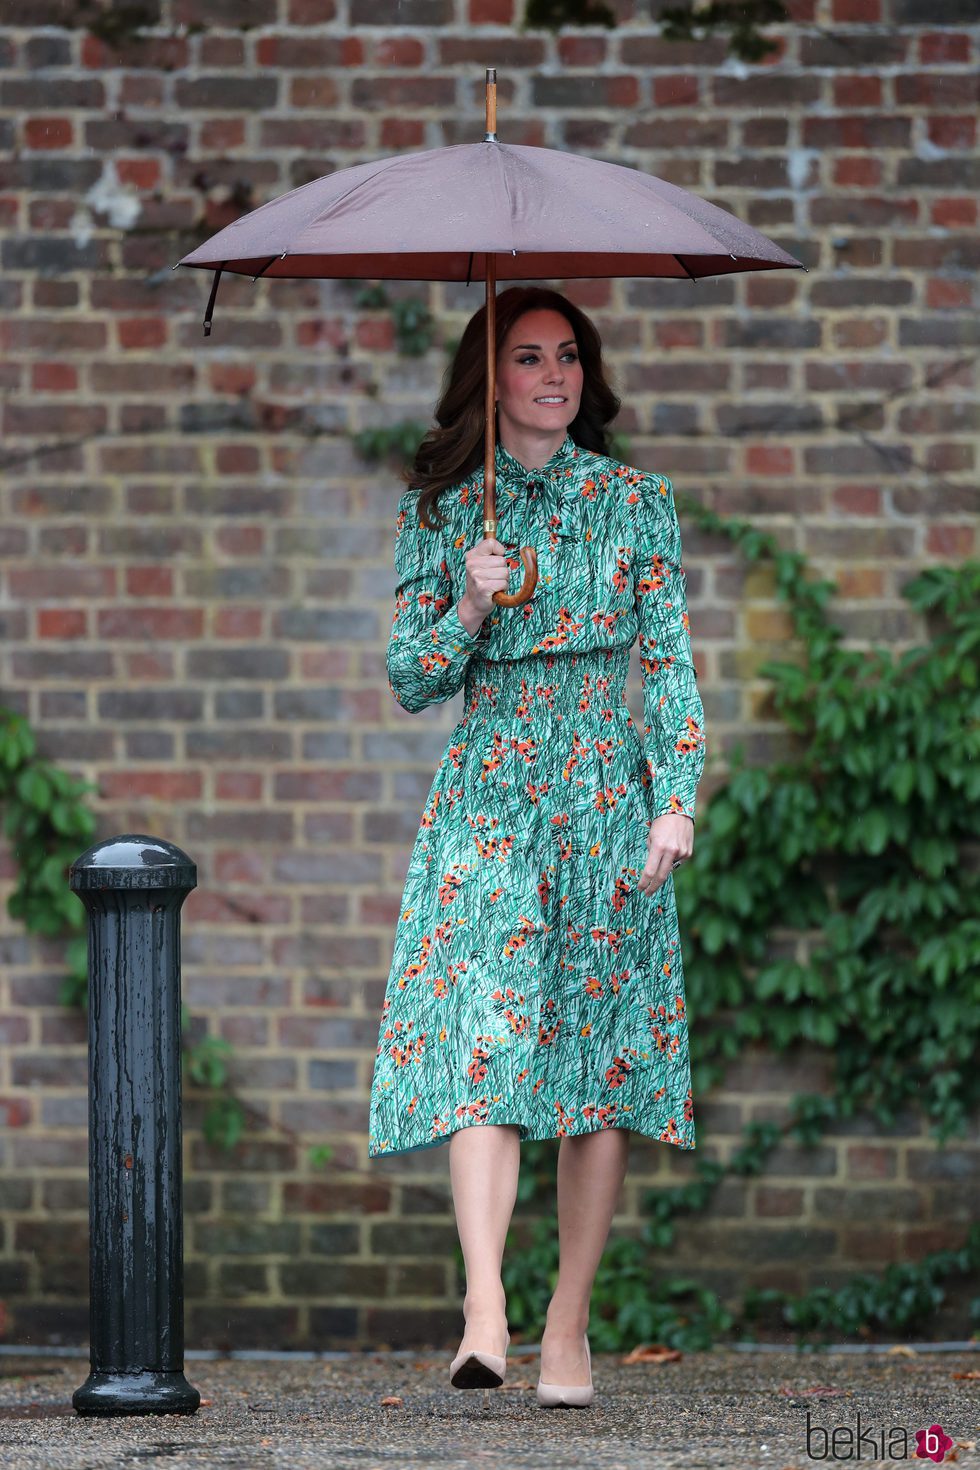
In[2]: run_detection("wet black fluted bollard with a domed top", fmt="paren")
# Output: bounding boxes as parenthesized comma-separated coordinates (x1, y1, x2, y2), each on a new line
(69, 833, 201, 1416)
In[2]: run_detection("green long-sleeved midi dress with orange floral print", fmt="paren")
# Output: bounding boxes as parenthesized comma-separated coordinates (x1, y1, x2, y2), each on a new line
(367, 435, 705, 1157)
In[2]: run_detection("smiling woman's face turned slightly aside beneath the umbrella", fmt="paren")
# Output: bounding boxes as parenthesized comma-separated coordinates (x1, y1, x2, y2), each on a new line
(497, 307, 583, 435)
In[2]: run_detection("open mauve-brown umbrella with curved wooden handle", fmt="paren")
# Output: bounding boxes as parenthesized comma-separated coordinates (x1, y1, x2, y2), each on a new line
(173, 66, 807, 607)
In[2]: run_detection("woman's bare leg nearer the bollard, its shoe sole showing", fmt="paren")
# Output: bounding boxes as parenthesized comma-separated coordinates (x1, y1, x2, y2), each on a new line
(450, 1123, 520, 1357)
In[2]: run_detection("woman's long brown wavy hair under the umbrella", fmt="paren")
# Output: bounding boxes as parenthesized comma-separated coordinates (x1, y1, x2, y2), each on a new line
(401, 285, 620, 531)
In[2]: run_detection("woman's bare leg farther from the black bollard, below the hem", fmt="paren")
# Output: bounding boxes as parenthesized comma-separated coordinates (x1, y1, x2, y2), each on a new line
(541, 1127, 629, 1386)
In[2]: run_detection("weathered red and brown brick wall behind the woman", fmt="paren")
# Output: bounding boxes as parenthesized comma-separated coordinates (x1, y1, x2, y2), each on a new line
(0, 0, 980, 1347)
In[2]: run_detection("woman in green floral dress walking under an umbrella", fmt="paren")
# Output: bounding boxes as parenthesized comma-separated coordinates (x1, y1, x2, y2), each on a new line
(369, 287, 705, 1404)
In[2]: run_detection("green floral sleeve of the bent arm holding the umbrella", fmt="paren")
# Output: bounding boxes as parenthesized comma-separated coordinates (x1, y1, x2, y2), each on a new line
(386, 491, 486, 713)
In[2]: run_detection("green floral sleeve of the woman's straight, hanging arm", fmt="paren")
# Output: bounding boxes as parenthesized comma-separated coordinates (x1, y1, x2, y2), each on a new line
(636, 475, 705, 820)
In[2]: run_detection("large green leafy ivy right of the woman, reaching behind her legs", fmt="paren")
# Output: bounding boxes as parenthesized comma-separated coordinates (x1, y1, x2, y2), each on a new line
(499, 535, 980, 1351)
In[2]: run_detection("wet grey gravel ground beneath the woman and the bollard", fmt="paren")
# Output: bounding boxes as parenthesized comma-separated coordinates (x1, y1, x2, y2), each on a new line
(0, 1345, 980, 1470)
